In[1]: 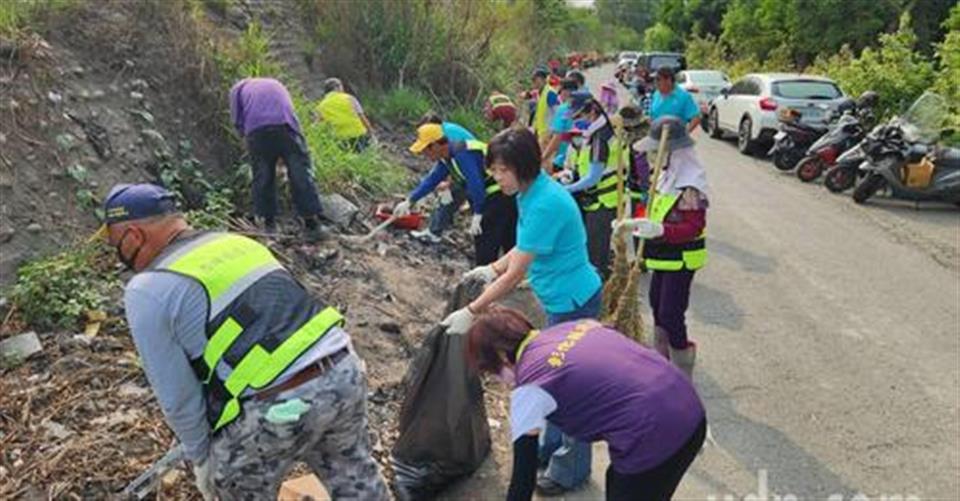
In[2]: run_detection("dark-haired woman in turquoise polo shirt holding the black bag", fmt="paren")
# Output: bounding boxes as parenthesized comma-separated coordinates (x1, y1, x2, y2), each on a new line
(443, 129, 603, 495)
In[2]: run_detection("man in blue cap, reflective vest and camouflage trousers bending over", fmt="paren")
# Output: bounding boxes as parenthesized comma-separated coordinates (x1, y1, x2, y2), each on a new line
(101, 184, 388, 501)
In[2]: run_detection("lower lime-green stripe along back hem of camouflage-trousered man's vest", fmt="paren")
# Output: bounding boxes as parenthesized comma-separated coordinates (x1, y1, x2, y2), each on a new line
(213, 307, 343, 431)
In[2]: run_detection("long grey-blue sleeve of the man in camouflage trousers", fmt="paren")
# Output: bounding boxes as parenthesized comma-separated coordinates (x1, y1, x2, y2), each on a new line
(124, 282, 210, 462)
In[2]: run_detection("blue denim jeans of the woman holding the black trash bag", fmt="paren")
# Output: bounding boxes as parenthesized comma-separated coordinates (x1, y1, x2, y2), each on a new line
(539, 289, 603, 489)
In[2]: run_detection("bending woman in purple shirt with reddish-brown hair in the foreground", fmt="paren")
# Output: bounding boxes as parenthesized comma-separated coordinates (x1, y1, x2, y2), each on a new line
(467, 307, 707, 500)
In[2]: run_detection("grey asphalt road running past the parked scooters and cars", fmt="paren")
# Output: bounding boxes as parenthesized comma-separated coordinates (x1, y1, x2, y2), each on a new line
(568, 67, 960, 500)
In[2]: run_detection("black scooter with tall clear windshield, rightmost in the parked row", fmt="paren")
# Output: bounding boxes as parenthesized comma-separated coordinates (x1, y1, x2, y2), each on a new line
(853, 92, 960, 205)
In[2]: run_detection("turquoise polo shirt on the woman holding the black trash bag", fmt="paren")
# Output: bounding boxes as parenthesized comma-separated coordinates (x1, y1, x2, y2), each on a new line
(517, 172, 602, 315)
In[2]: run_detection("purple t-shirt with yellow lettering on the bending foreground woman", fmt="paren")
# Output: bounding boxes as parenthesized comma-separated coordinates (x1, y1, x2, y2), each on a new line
(516, 321, 705, 475)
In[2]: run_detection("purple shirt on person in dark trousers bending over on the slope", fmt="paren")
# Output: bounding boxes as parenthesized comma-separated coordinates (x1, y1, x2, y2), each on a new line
(230, 78, 300, 136)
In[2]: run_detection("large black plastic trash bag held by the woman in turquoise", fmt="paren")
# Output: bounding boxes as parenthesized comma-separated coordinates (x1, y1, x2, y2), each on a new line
(391, 281, 543, 501)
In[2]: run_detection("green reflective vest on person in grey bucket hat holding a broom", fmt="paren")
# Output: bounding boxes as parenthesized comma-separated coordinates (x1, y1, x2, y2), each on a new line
(643, 193, 707, 271)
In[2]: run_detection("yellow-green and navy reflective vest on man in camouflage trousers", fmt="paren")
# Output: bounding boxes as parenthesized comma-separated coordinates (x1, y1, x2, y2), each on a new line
(149, 233, 343, 432)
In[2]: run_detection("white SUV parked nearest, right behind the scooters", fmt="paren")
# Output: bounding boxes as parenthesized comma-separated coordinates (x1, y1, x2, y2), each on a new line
(708, 73, 846, 154)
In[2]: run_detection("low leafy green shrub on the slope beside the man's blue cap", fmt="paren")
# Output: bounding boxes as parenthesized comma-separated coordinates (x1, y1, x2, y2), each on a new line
(10, 245, 121, 330)
